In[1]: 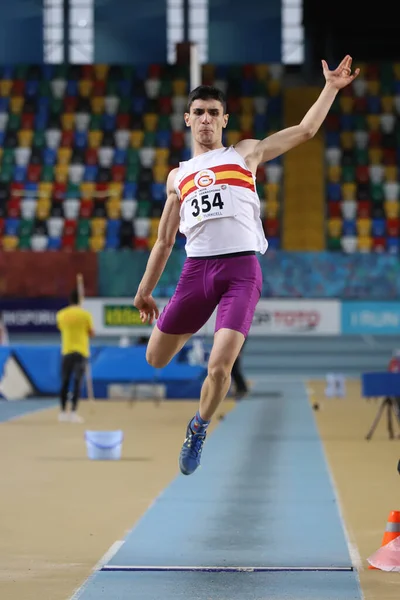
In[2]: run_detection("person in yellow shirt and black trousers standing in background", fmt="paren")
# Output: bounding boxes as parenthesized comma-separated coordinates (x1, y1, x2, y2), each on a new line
(57, 291, 94, 423)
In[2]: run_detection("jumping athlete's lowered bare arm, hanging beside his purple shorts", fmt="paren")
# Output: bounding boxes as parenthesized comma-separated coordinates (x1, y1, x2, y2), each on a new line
(133, 169, 179, 324)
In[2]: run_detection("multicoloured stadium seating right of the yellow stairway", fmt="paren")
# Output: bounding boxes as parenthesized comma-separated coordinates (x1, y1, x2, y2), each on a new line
(325, 63, 400, 254)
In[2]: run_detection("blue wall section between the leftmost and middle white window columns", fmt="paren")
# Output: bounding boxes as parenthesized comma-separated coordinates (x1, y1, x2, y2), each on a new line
(95, 0, 167, 64)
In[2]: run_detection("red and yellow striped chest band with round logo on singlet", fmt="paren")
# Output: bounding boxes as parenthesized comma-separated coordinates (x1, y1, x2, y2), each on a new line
(178, 164, 255, 203)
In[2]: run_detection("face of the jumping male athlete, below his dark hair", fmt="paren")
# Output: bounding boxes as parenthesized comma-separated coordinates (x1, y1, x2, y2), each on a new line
(185, 100, 228, 146)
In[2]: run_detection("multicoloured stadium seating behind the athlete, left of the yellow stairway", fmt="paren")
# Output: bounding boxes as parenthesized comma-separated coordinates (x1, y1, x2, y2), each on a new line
(0, 65, 282, 252)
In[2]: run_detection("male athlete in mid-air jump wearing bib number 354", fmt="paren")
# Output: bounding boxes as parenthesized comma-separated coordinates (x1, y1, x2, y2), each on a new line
(134, 56, 359, 475)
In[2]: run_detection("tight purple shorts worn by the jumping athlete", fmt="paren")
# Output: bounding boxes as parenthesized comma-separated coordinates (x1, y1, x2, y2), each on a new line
(157, 254, 262, 337)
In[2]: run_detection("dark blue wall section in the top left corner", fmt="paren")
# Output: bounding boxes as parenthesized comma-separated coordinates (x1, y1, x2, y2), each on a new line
(0, 0, 43, 64)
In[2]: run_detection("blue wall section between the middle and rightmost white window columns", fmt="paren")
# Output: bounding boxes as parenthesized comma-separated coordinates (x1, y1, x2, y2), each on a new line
(209, 0, 281, 64)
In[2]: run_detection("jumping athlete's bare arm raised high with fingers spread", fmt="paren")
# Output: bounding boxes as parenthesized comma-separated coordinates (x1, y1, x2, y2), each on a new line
(235, 55, 360, 172)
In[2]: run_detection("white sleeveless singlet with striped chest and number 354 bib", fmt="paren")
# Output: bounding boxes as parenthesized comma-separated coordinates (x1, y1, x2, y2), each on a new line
(175, 146, 268, 258)
